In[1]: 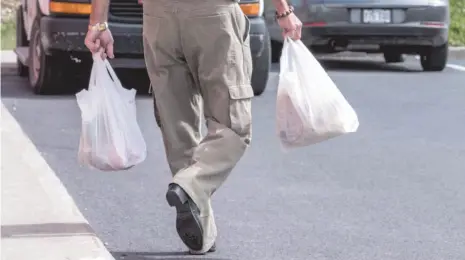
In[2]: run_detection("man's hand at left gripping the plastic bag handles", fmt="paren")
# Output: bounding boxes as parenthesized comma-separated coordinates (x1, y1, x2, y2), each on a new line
(85, 28, 115, 59)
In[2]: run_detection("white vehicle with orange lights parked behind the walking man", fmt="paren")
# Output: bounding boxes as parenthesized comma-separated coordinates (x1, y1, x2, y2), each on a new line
(16, 0, 271, 95)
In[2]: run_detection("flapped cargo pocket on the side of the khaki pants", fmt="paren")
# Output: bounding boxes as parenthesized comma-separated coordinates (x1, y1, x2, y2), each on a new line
(229, 85, 254, 144)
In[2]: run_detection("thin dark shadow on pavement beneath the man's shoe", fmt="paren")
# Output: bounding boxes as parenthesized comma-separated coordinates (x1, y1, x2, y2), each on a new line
(111, 252, 229, 260)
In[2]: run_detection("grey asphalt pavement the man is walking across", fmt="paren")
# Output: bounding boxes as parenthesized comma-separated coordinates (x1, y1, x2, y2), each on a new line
(1, 55, 465, 260)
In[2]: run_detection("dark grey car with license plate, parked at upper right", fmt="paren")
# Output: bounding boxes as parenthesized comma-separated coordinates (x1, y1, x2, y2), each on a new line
(265, 0, 450, 71)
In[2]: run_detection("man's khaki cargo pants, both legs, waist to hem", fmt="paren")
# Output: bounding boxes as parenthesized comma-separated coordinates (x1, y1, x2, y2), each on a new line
(143, 0, 253, 252)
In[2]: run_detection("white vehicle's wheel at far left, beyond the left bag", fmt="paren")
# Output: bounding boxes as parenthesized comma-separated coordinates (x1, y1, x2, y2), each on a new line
(29, 18, 65, 95)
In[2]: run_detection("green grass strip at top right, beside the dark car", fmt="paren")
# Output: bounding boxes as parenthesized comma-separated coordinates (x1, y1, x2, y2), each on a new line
(449, 0, 465, 46)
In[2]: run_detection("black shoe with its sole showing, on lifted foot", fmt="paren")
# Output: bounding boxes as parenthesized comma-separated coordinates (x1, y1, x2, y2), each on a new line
(166, 183, 203, 251)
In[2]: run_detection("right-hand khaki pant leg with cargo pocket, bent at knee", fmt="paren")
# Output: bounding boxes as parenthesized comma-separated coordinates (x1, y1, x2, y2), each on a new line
(174, 0, 253, 251)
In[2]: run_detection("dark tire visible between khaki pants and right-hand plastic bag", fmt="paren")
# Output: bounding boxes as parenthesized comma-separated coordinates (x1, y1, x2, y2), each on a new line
(252, 34, 271, 96)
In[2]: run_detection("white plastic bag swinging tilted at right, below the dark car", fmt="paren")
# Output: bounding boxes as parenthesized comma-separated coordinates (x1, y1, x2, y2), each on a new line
(276, 38, 359, 148)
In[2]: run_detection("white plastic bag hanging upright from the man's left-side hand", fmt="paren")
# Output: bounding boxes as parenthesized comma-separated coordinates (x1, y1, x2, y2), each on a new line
(76, 53, 147, 171)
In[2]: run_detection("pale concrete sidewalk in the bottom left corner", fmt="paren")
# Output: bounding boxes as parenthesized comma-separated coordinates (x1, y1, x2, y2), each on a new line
(1, 104, 114, 260)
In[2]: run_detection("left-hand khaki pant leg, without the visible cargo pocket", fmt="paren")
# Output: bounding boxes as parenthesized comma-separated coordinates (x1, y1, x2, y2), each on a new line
(143, 0, 201, 175)
